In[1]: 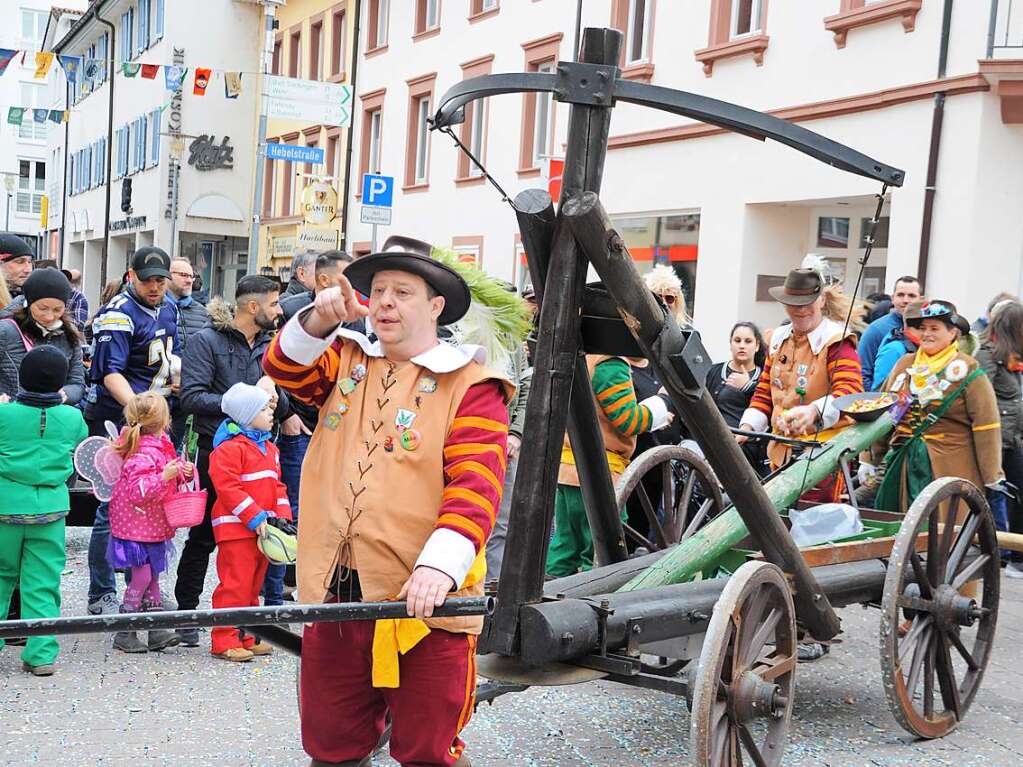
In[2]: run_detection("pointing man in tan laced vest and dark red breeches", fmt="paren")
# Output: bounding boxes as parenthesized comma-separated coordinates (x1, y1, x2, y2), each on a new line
(264, 237, 513, 765)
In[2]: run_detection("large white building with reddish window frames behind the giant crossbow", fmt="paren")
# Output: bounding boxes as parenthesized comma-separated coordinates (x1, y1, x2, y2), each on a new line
(347, 0, 1023, 358)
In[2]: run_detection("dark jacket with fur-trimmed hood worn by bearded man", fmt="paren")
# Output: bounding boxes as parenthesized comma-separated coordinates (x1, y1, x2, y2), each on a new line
(180, 299, 292, 438)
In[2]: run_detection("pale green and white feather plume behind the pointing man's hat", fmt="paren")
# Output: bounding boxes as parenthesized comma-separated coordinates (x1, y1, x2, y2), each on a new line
(430, 246, 533, 372)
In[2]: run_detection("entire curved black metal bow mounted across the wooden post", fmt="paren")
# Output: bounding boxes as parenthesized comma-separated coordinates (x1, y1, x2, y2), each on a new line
(433, 71, 905, 186)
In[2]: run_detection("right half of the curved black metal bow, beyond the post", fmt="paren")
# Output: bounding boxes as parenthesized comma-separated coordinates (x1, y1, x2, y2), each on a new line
(615, 80, 905, 186)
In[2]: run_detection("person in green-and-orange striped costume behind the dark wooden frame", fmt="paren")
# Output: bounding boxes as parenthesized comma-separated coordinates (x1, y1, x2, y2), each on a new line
(546, 355, 672, 578)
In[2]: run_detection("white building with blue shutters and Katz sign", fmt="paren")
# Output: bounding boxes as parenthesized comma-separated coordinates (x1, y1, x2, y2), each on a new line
(51, 0, 262, 302)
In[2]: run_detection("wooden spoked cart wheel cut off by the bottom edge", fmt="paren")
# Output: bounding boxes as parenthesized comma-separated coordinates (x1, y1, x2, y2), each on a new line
(690, 561, 797, 767)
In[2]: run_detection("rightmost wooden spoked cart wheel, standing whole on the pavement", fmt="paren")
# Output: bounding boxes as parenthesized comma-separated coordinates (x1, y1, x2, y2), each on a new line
(881, 477, 1000, 737)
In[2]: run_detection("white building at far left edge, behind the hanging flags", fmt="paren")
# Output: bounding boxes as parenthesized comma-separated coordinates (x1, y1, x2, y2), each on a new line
(0, 0, 68, 257)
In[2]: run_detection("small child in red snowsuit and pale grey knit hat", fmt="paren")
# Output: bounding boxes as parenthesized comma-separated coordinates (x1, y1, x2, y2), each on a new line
(210, 384, 292, 662)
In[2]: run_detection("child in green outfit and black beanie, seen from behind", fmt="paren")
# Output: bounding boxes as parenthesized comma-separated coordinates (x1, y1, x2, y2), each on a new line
(0, 346, 89, 676)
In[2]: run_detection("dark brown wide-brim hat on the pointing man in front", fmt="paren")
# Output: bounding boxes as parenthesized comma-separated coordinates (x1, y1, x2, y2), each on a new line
(345, 236, 473, 325)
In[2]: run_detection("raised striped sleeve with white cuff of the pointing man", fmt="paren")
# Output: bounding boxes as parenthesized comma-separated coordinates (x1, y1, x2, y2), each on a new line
(263, 316, 345, 407)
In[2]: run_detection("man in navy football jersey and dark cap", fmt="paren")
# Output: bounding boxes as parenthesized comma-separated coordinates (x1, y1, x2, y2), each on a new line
(85, 247, 178, 615)
